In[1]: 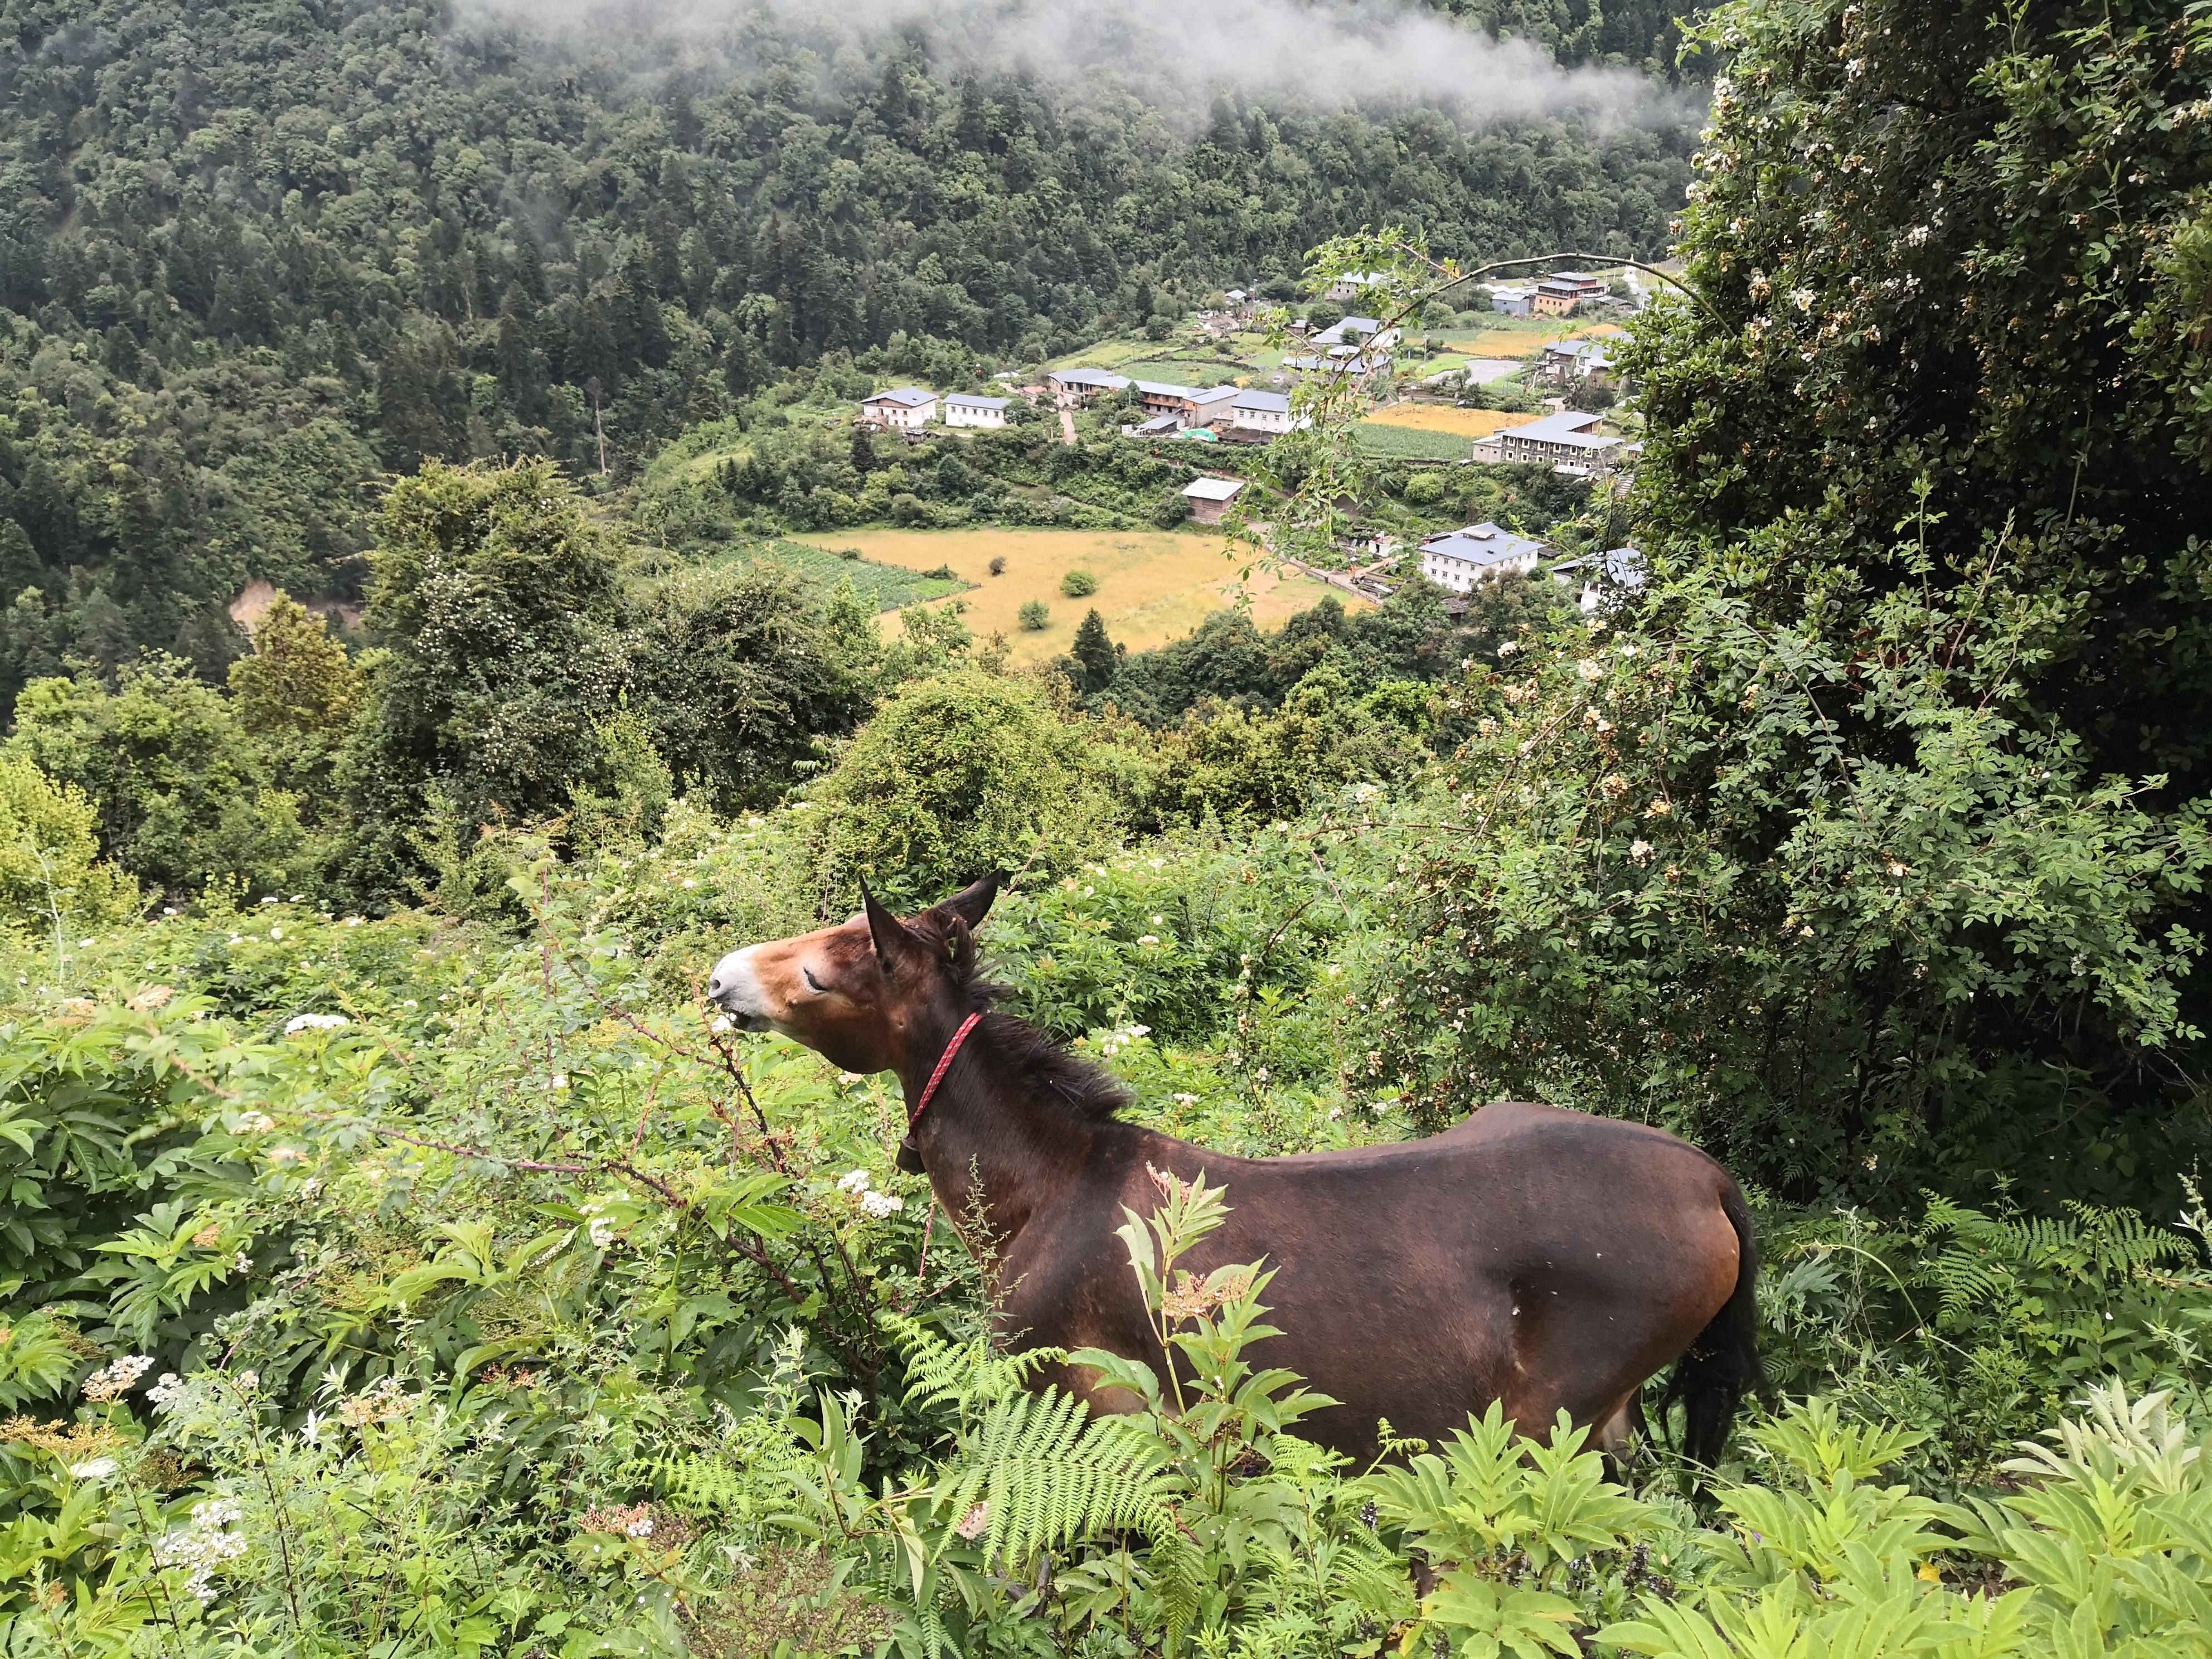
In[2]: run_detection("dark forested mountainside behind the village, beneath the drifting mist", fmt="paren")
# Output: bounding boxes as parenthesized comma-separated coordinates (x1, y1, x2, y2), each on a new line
(0, 0, 1688, 686)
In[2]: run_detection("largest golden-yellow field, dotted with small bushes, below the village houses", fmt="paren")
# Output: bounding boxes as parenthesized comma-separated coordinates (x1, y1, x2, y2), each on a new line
(796, 528, 1365, 661)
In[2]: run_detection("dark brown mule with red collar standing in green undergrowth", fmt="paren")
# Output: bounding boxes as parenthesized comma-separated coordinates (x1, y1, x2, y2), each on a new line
(708, 876, 1761, 1464)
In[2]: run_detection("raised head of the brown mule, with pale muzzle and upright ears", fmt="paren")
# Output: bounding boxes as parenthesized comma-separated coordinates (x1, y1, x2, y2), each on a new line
(706, 874, 1004, 1073)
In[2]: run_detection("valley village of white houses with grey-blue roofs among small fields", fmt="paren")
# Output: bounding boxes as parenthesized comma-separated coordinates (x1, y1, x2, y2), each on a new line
(836, 270, 1643, 610)
